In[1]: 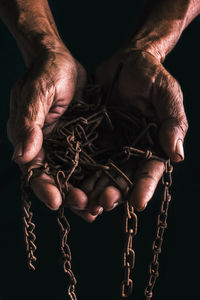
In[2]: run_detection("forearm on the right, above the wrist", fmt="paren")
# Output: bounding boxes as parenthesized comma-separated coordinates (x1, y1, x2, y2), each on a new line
(131, 0, 200, 62)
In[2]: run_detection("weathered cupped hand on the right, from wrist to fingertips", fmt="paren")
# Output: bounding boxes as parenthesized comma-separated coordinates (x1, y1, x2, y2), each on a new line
(76, 50, 188, 218)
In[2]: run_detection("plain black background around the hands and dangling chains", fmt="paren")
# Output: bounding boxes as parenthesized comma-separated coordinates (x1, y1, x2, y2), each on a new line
(0, 1, 200, 300)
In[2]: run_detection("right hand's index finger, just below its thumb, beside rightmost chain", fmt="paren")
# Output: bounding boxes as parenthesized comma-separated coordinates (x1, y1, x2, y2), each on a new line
(128, 160, 164, 211)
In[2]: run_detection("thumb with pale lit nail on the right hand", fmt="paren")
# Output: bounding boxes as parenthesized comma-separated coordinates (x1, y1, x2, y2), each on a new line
(152, 68, 188, 162)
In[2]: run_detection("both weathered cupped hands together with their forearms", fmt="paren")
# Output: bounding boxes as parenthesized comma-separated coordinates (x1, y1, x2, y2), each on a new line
(0, 0, 200, 222)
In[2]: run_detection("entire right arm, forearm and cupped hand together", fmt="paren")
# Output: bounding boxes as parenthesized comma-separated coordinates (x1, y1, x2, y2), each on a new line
(71, 0, 200, 220)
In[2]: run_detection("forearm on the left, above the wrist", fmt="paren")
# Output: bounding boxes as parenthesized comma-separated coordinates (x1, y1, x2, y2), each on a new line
(0, 0, 67, 65)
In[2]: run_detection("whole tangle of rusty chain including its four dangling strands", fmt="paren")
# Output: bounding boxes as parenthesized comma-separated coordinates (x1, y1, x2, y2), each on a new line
(19, 79, 172, 300)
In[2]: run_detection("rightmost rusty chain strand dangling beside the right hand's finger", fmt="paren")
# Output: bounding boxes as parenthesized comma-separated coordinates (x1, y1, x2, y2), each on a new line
(144, 160, 173, 300)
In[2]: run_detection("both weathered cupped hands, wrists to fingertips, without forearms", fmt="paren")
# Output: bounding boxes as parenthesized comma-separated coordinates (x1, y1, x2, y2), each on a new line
(7, 46, 188, 222)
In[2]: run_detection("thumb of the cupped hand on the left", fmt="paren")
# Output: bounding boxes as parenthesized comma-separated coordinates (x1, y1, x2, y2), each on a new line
(7, 85, 50, 164)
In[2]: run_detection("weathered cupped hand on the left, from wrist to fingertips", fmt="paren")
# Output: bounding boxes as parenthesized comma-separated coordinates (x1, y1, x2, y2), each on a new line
(7, 46, 86, 210)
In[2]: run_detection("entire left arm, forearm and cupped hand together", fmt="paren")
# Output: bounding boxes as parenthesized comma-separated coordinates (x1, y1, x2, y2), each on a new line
(0, 0, 91, 214)
